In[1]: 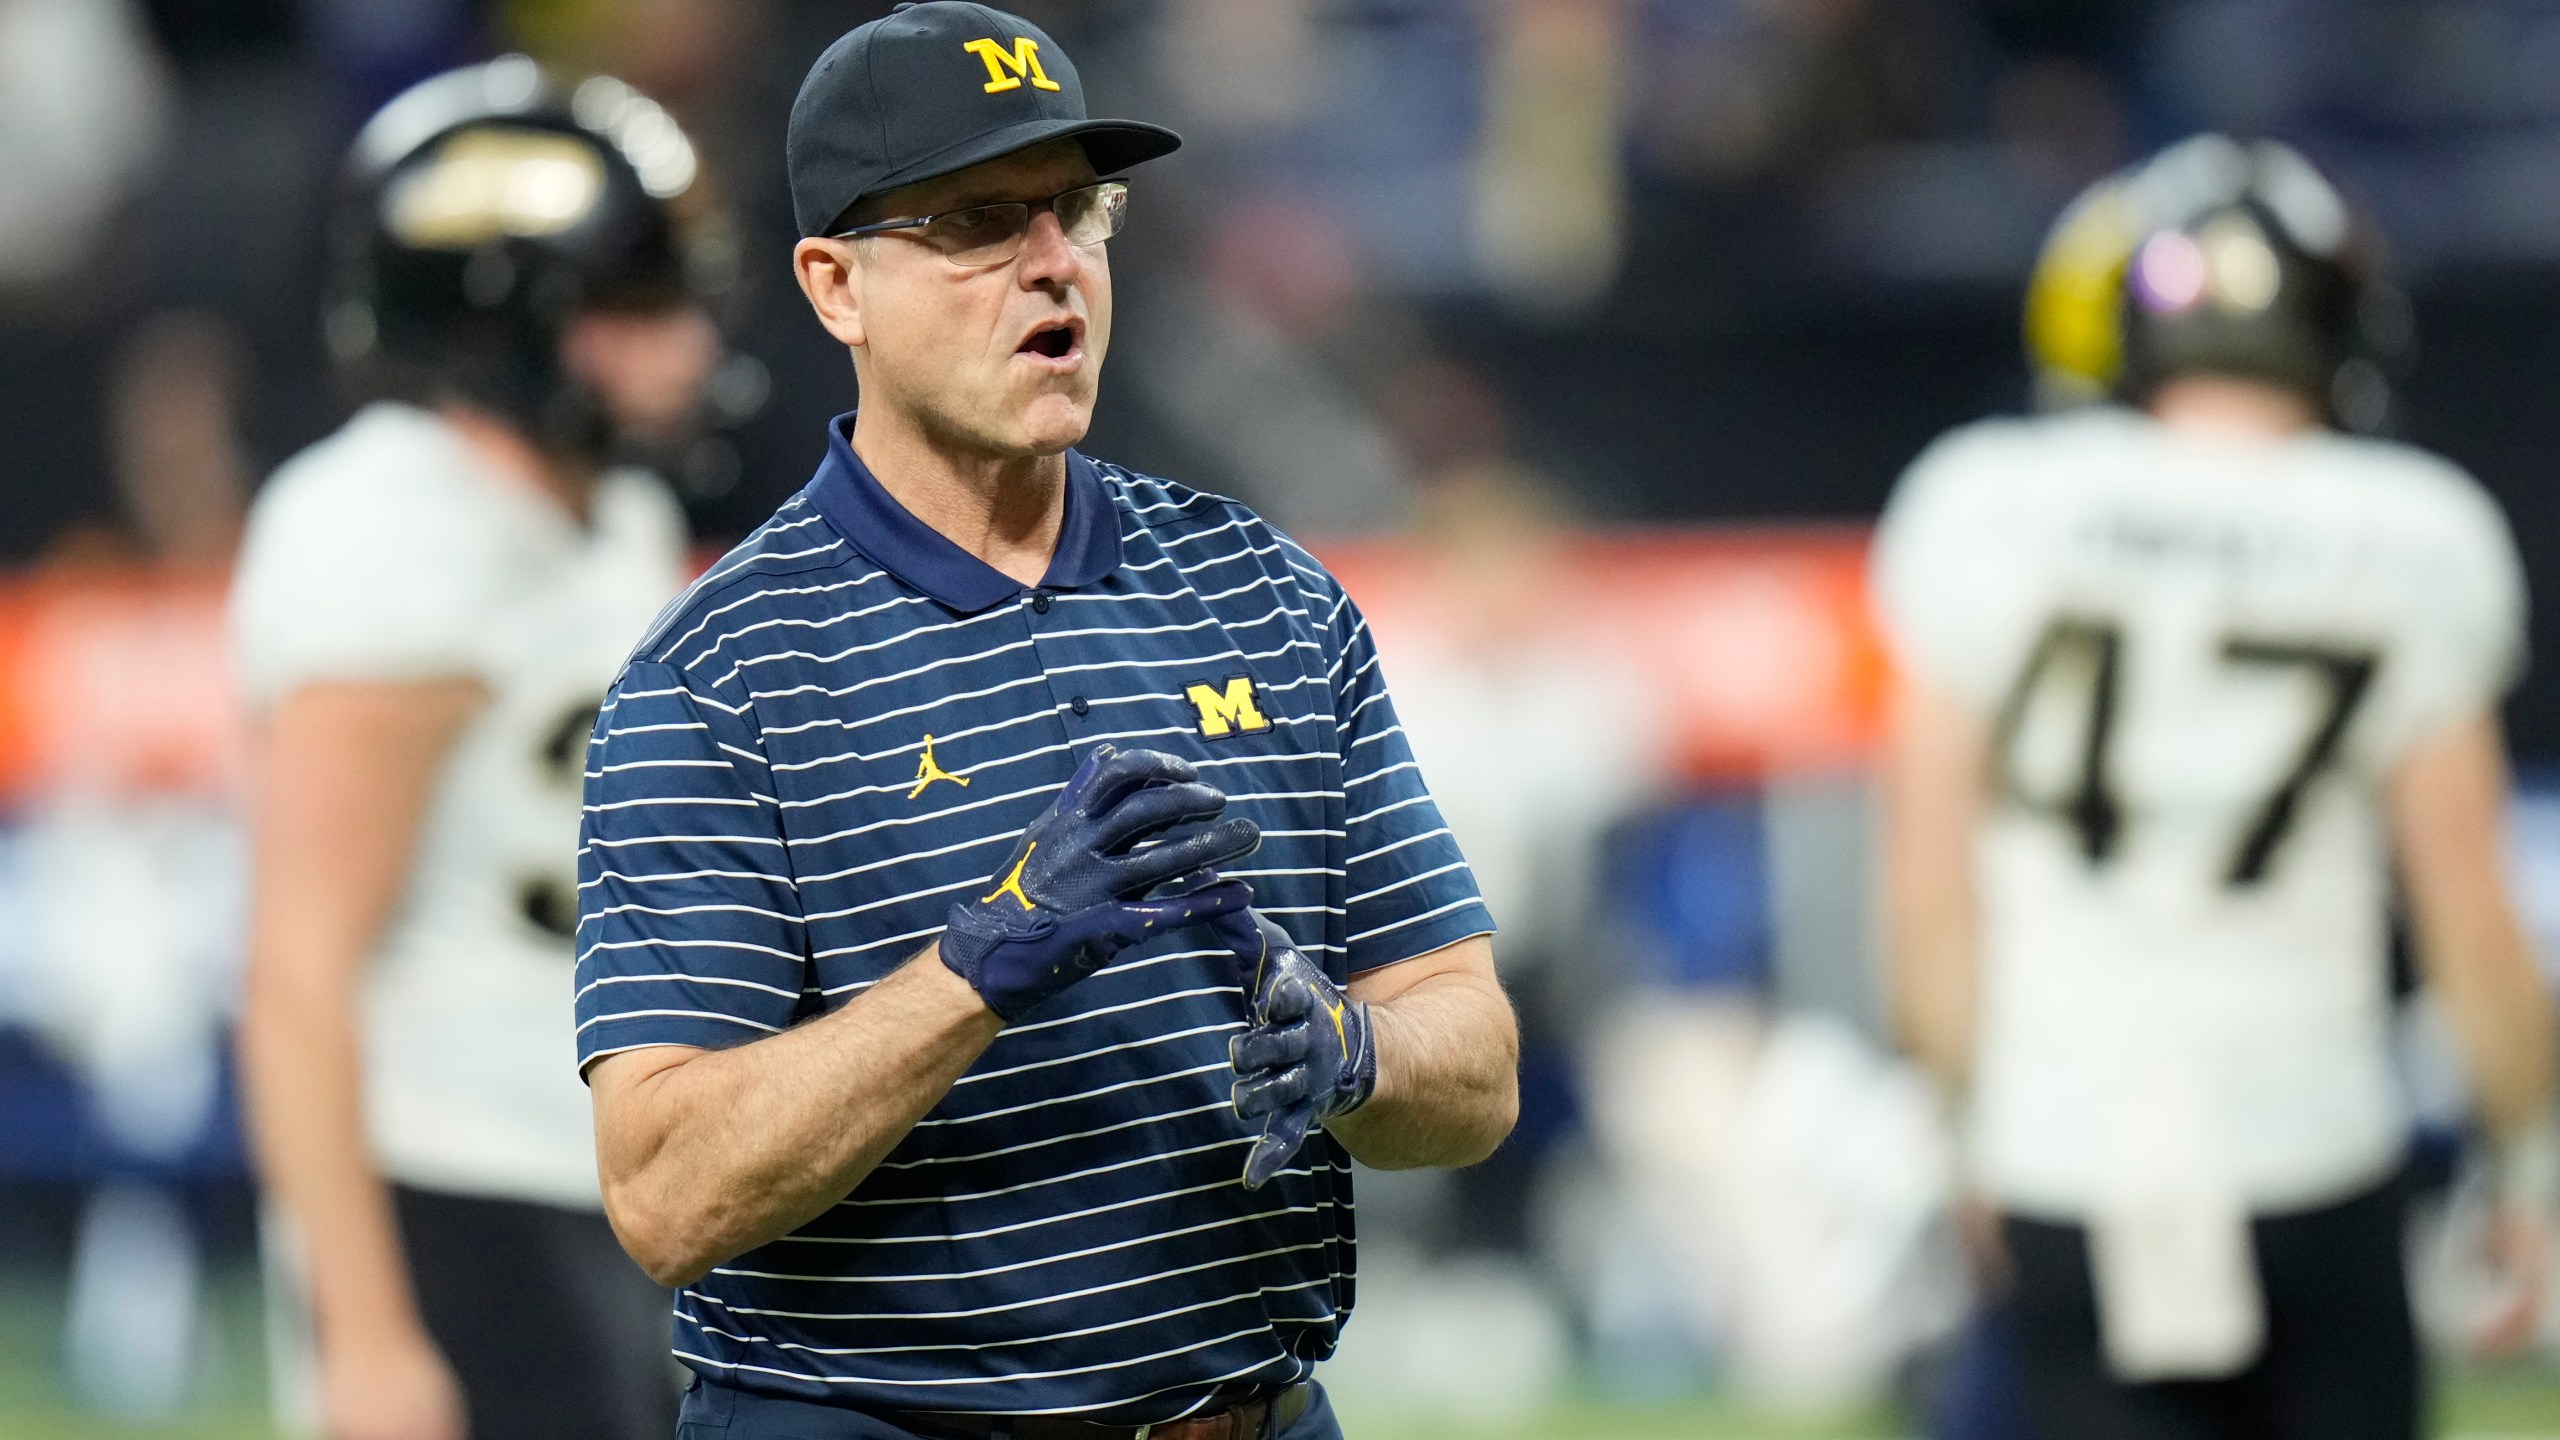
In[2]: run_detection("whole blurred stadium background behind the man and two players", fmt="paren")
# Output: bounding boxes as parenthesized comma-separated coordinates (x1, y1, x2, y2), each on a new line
(0, 0, 2560, 1440)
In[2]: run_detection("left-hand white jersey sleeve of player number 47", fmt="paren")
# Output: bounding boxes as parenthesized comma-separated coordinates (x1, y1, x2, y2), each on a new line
(1871, 430, 2033, 707)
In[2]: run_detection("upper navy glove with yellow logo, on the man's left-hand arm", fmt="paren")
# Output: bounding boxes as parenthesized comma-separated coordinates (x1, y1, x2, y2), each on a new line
(942, 746, 1262, 1022)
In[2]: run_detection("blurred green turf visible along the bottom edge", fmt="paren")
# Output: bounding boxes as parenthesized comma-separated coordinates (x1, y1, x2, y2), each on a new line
(0, 1276, 2560, 1440)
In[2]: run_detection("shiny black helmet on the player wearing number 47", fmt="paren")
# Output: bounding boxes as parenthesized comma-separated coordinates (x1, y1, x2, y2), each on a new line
(2028, 136, 2409, 430)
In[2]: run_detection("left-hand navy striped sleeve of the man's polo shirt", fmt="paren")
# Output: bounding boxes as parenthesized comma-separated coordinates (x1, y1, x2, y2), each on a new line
(576, 664, 806, 1074)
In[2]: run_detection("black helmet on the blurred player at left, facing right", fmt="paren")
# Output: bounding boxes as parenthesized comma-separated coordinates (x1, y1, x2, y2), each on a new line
(325, 56, 717, 459)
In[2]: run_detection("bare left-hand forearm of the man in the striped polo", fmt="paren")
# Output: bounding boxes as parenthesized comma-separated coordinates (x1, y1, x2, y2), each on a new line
(596, 948, 1004, 1284)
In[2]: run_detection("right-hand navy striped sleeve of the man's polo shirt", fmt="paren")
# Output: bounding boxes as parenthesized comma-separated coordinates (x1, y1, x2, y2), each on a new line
(1326, 576, 1492, 974)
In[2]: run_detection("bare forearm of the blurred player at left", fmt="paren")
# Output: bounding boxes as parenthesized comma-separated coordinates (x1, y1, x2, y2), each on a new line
(241, 961, 420, 1345)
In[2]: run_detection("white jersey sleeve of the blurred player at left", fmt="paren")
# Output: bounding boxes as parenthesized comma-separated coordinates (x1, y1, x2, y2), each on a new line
(230, 448, 504, 705)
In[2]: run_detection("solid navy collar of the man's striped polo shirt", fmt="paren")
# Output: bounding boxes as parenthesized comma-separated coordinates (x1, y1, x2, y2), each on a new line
(809, 410, 1121, 615)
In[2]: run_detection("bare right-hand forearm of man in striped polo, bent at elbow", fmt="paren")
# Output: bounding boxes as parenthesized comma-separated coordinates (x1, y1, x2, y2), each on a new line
(1326, 974, 1521, 1171)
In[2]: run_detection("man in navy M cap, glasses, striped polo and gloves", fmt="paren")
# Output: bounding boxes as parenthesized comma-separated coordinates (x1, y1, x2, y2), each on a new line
(579, 3, 1516, 1440)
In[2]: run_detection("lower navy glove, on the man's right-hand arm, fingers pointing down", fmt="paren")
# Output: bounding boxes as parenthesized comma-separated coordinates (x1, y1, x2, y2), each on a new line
(1216, 910, 1377, 1189)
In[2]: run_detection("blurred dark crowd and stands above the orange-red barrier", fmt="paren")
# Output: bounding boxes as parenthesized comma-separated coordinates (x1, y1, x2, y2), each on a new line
(24, 0, 2560, 559)
